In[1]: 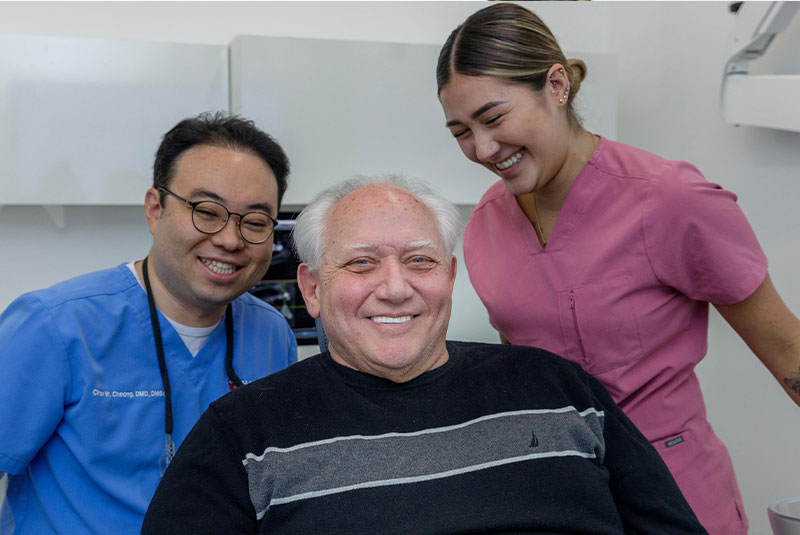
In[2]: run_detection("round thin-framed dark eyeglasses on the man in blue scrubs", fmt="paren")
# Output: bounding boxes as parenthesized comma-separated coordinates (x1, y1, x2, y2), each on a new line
(158, 187, 278, 244)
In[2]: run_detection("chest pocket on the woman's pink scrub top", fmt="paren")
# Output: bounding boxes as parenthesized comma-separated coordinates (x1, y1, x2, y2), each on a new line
(558, 277, 643, 375)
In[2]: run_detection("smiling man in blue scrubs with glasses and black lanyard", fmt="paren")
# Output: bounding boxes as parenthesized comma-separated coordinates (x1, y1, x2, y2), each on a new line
(0, 114, 297, 535)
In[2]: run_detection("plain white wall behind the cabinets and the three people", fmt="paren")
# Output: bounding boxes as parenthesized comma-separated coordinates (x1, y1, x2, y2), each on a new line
(0, 2, 800, 535)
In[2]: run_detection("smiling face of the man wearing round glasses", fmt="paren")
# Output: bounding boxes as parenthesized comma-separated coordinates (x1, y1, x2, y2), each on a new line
(145, 145, 278, 326)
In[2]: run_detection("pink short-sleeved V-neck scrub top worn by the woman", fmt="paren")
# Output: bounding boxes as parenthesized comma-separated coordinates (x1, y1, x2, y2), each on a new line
(464, 138, 767, 535)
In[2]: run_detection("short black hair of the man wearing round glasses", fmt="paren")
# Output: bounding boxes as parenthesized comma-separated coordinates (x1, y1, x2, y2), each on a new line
(153, 111, 289, 206)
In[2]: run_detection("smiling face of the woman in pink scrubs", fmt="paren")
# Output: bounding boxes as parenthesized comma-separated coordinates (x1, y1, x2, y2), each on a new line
(439, 72, 577, 195)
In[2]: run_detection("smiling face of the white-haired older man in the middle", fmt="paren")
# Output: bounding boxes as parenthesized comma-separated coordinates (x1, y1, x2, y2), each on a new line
(298, 184, 456, 382)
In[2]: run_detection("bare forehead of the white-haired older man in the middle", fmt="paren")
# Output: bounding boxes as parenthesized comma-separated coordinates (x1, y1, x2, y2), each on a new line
(325, 184, 444, 252)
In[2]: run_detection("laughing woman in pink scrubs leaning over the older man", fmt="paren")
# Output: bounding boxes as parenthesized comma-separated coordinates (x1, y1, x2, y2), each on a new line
(437, 4, 800, 535)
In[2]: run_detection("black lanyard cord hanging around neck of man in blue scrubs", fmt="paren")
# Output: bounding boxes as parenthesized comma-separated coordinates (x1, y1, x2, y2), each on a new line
(142, 257, 242, 475)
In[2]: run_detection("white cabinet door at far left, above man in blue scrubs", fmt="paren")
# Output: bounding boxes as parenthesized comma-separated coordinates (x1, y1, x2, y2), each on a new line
(0, 36, 228, 205)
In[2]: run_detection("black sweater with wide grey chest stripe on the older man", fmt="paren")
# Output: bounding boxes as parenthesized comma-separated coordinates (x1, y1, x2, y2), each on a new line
(142, 342, 706, 535)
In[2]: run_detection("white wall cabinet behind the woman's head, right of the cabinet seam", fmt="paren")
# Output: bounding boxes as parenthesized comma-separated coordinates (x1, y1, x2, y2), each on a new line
(230, 36, 616, 205)
